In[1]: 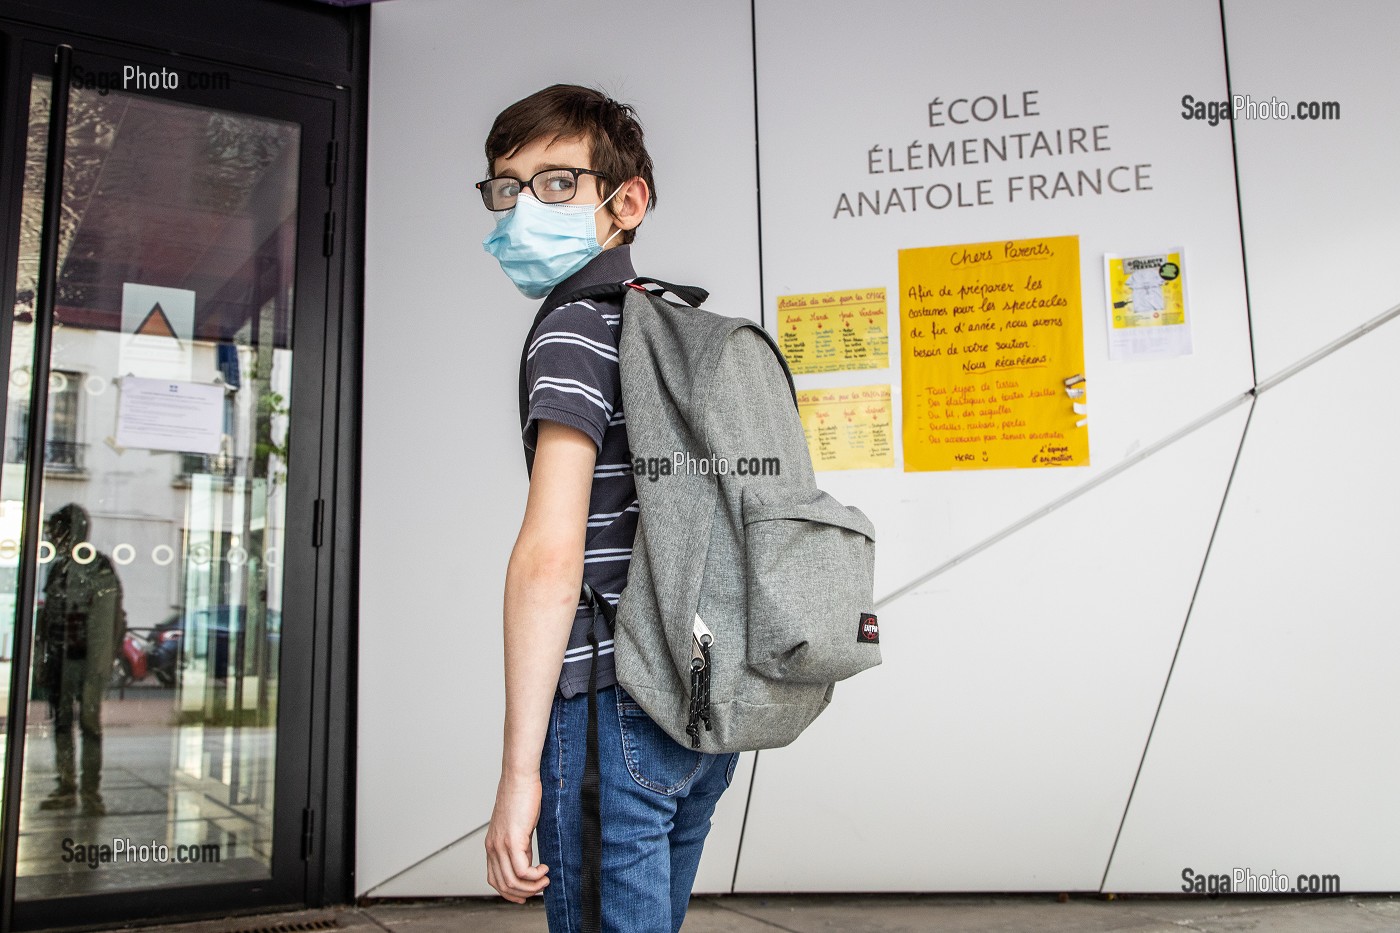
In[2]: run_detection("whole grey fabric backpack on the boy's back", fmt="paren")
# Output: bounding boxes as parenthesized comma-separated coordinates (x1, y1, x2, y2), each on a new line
(585, 279, 881, 752)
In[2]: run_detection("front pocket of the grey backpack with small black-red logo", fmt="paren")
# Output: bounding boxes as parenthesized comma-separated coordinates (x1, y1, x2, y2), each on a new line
(743, 489, 881, 684)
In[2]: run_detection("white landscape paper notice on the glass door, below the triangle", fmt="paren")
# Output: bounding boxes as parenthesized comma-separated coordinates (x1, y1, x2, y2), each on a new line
(116, 375, 224, 454)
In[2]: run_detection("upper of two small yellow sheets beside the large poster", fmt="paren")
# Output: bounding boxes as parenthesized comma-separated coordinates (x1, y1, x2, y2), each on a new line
(778, 289, 889, 374)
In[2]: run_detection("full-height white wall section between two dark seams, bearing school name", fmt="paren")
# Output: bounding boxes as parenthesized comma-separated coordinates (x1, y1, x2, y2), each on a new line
(736, 0, 1252, 891)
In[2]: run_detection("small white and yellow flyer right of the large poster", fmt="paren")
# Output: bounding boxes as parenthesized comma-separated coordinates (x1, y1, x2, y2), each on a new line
(1103, 249, 1191, 360)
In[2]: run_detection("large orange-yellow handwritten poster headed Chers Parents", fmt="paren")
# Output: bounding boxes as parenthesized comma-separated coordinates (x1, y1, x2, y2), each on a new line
(899, 237, 1089, 471)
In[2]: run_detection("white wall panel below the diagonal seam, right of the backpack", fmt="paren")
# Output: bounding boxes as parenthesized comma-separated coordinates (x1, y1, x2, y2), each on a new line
(738, 406, 1246, 891)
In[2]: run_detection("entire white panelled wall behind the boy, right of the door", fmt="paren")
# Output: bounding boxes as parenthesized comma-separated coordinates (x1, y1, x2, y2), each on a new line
(357, 0, 1400, 897)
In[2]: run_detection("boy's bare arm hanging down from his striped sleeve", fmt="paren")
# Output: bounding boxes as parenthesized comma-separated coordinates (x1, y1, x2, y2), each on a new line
(486, 420, 598, 904)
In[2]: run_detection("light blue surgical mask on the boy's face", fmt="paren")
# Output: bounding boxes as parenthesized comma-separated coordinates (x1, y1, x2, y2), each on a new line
(482, 188, 622, 298)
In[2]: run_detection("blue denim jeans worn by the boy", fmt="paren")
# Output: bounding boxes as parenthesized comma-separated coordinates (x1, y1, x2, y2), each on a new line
(538, 675, 739, 933)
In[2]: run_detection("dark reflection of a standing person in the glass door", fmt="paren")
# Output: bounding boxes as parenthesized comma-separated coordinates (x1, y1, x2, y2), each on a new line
(35, 503, 126, 817)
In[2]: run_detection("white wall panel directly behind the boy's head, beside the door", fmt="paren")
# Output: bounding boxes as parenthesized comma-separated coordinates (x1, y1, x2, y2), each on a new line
(356, 0, 759, 897)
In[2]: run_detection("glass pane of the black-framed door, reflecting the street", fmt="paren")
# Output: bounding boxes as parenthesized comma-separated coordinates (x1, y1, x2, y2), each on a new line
(0, 70, 302, 901)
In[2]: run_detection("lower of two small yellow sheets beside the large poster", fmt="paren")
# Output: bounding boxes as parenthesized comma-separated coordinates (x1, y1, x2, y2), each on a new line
(797, 385, 895, 469)
